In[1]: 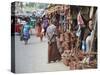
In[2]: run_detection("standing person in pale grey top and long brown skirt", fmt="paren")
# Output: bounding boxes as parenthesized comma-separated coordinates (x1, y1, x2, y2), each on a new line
(46, 19, 61, 63)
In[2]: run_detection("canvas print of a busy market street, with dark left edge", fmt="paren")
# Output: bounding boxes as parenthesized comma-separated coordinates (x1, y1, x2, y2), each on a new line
(11, 2, 98, 73)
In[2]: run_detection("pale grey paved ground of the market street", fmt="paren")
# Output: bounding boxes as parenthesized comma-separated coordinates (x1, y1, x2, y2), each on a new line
(15, 36, 69, 73)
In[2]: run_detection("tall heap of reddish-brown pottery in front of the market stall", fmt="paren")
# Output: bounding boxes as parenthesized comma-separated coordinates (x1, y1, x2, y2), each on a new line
(61, 32, 83, 69)
